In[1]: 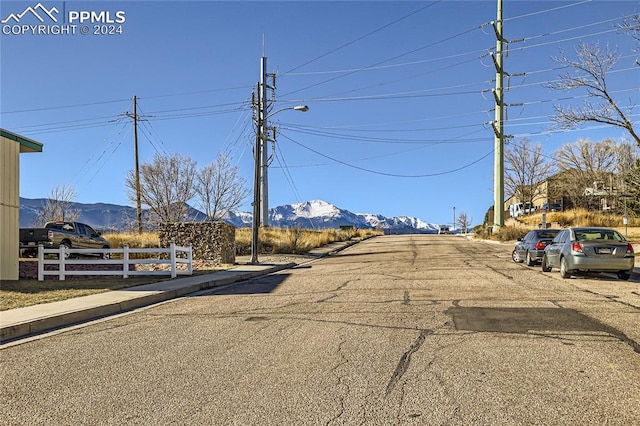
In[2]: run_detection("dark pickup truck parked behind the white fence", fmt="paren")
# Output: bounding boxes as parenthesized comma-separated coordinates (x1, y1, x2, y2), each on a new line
(20, 222, 111, 257)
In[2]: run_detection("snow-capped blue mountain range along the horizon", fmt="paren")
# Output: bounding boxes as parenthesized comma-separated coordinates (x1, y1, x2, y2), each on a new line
(20, 198, 439, 234)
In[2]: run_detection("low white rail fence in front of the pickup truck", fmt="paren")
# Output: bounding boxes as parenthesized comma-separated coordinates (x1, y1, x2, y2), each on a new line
(38, 242, 193, 281)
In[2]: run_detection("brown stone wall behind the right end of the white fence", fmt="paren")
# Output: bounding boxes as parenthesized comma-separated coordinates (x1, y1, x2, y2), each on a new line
(158, 222, 236, 263)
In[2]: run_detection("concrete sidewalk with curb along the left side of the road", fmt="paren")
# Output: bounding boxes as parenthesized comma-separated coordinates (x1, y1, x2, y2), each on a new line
(0, 242, 356, 344)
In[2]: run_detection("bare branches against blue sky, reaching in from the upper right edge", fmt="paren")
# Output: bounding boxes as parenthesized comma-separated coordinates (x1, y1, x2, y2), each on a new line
(548, 43, 640, 147)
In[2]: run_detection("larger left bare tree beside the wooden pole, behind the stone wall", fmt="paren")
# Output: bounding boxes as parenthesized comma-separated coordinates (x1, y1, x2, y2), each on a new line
(125, 154, 197, 226)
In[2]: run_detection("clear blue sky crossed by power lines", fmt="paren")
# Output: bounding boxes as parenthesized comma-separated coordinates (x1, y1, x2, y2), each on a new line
(0, 0, 640, 225)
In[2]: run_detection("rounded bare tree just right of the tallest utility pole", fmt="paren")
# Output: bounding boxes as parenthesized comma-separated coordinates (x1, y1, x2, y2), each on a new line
(504, 138, 551, 205)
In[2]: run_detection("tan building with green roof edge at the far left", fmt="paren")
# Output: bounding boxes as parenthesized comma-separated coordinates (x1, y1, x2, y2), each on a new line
(0, 129, 42, 280)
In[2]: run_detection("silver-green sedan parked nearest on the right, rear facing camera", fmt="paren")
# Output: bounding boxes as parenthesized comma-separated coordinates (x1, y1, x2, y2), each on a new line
(542, 228, 635, 280)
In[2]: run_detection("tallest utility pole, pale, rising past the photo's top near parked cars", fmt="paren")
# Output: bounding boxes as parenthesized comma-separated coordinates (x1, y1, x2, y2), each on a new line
(491, 0, 504, 231)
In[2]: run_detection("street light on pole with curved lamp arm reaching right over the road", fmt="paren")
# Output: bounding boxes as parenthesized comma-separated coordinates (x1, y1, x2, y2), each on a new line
(250, 104, 309, 263)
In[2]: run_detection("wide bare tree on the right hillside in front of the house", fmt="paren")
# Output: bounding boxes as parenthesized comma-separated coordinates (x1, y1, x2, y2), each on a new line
(555, 139, 620, 208)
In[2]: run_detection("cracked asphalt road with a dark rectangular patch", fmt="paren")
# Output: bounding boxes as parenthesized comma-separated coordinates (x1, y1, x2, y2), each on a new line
(0, 235, 640, 425)
